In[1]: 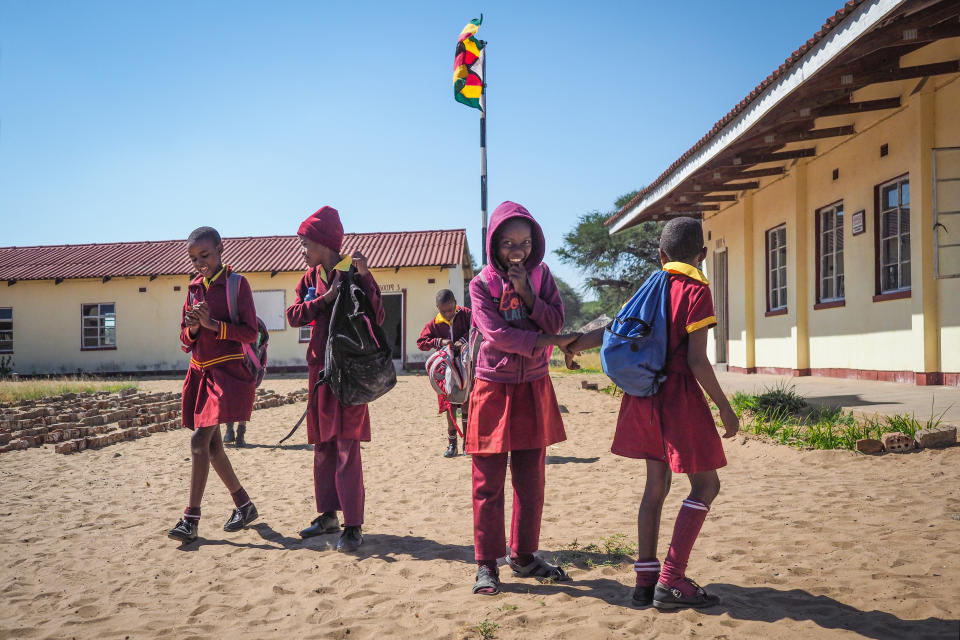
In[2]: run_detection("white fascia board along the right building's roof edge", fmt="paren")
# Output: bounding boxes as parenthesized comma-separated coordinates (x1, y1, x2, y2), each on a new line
(610, 0, 907, 234)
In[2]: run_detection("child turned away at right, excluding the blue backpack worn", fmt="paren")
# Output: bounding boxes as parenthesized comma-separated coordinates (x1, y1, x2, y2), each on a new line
(569, 218, 739, 609)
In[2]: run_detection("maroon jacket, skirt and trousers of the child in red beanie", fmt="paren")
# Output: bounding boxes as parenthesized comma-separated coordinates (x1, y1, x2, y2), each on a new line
(287, 259, 384, 526)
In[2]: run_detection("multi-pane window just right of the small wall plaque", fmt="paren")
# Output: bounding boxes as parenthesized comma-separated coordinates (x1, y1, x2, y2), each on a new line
(876, 177, 910, 294)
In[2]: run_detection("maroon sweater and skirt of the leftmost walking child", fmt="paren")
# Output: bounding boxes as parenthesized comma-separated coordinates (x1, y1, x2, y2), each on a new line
(180, 267, 257, 429)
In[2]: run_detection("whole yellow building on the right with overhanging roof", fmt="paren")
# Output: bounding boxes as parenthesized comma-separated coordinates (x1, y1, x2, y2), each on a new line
(608, 0, 960, 386)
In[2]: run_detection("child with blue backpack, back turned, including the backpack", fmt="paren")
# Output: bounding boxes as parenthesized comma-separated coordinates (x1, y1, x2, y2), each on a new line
(566, 218, 739, 609)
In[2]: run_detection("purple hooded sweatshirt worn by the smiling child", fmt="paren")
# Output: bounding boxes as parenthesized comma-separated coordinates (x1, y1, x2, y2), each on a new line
(470, 201, 563, 384)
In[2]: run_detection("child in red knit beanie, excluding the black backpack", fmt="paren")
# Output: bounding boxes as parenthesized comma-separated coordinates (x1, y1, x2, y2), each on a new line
(287, 207, 384, 551)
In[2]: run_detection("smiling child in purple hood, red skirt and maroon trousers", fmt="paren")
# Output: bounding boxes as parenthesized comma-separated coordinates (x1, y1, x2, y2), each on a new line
(465, 202, 577, 595)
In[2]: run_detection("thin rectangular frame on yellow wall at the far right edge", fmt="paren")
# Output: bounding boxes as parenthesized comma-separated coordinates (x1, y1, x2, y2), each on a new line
(933, 147, 960, 278)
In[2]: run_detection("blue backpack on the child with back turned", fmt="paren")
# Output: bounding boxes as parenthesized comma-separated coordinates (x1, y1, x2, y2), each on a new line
(600, 271, 670, 398)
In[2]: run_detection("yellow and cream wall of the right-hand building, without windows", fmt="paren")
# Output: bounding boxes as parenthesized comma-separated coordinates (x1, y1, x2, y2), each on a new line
(704, 71, 960, 380)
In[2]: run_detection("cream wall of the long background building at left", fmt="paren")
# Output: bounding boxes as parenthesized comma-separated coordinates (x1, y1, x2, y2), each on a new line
(0, 266, 464, 375)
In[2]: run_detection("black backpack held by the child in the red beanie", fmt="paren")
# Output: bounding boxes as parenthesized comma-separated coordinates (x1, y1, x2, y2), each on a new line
(320, 267, 397, 406)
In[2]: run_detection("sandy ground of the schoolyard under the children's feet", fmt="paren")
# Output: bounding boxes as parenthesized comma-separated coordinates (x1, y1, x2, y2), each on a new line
(0, 375, 960, 640)
